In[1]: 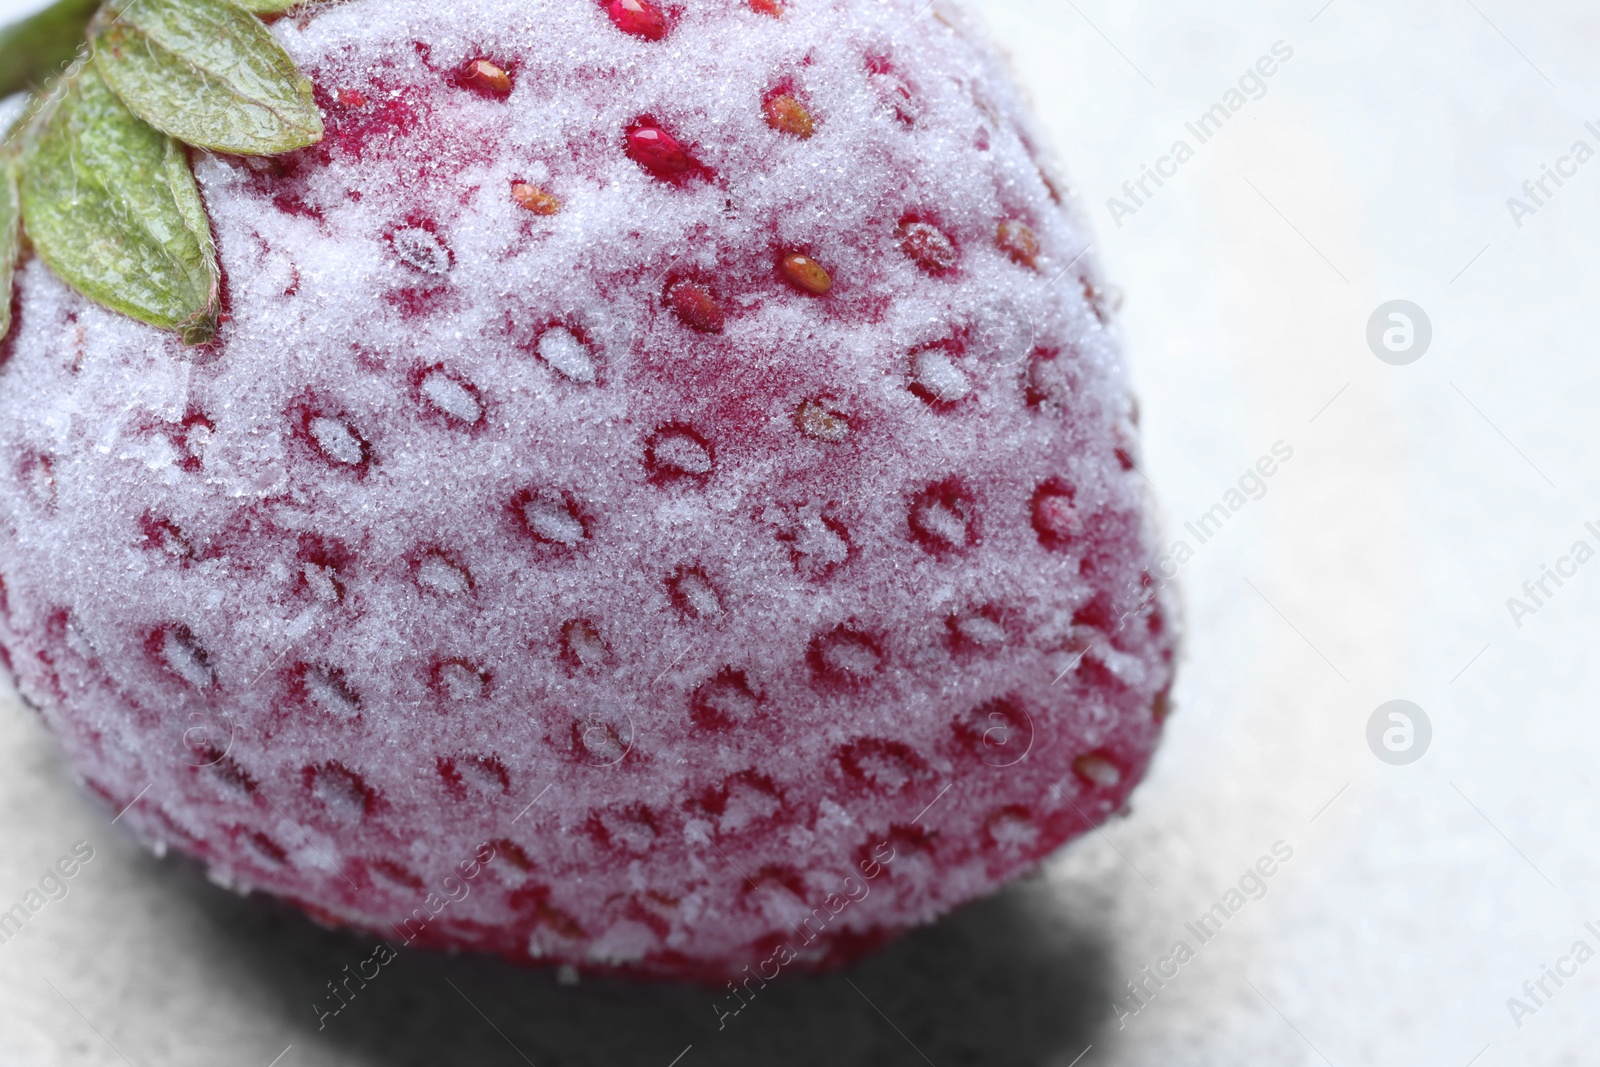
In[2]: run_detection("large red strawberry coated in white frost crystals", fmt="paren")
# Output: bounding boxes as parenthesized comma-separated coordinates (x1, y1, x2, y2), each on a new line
(0, 0, 1174, 977)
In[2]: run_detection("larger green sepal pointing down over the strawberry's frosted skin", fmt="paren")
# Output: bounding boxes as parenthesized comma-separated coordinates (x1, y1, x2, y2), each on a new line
(21, 59, 221, 344)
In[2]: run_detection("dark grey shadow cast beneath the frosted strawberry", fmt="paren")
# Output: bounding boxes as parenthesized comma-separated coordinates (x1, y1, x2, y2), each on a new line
(150, 857, 1114, 1067)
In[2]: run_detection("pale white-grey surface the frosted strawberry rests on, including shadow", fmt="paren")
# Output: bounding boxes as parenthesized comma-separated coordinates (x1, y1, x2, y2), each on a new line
(0, 0, 1600, 1067)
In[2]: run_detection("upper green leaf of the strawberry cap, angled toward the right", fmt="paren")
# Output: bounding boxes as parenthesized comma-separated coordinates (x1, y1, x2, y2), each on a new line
(90, 0, 322, 155)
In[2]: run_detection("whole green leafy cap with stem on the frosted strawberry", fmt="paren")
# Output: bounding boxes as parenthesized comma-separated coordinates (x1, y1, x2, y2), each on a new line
(0, 0, 321, 347)
